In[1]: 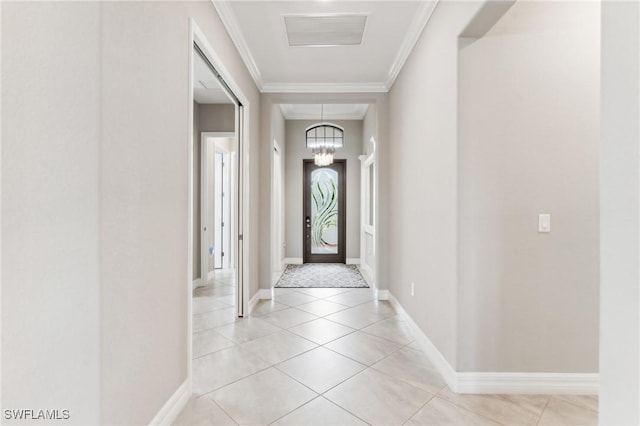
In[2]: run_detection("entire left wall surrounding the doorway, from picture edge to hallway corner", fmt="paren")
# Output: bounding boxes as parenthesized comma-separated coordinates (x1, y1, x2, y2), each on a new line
(2, 2, 259, 424)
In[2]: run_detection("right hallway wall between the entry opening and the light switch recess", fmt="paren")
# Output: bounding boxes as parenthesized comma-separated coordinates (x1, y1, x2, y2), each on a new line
(379, 2, 480, 366)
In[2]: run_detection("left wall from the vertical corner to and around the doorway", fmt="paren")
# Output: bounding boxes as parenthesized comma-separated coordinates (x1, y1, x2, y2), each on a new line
(100, 2, 259, 424)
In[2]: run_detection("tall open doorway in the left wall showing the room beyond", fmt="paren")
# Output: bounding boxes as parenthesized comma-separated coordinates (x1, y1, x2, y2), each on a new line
(192, 35, 246, 317)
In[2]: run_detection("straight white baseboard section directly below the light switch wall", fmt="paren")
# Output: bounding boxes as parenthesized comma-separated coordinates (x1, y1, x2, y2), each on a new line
(456, 373, 599, 395)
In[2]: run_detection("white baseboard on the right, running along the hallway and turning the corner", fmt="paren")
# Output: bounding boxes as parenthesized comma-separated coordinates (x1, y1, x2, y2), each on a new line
(378, 290, 599, 395)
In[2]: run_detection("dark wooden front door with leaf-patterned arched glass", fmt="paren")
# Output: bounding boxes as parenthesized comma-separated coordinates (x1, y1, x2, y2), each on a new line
(302, 160, 347, 263)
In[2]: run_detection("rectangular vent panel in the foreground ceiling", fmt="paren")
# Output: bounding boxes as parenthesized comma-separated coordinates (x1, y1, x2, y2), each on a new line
(284, 14, 367, 47)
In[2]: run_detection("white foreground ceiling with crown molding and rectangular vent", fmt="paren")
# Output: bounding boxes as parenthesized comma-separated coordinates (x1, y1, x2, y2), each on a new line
(214, 0, 437, 93)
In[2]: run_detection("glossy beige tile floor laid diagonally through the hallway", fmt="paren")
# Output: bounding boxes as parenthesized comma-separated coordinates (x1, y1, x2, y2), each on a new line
(175, 272, 598, 425)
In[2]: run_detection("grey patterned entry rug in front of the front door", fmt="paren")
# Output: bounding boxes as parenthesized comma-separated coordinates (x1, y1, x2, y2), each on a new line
(276, 263, 369, 288)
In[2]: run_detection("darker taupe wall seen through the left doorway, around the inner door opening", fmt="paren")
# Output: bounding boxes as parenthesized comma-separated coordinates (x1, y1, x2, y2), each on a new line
(192, 102, 235, 278)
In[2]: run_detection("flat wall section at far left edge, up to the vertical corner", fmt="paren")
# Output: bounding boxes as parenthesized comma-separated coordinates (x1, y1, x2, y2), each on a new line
(1, 2, 100, 424)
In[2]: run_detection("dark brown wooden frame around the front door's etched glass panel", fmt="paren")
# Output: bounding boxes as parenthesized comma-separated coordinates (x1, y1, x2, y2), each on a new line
(302, 159, 347, 263)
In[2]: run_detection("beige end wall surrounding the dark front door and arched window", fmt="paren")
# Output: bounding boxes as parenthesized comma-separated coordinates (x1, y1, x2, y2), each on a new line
(285, 120, 362, 258)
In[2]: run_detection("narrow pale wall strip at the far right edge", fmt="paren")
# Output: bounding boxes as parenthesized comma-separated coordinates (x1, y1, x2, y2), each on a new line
(600, 1, 640, 425)
